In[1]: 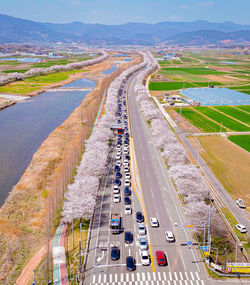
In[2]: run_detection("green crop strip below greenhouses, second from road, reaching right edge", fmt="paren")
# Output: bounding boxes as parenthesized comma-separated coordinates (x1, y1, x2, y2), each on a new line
(195, 107, 250, 132)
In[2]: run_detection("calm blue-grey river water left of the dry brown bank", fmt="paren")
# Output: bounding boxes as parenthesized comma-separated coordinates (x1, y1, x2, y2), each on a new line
(0, 78, 96, 206)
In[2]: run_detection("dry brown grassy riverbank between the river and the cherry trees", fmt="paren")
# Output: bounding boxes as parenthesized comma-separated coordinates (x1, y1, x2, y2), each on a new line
(0, 51, 141, 284)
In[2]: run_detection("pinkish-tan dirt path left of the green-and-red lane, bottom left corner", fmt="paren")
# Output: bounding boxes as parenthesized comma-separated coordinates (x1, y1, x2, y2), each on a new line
(16, 240, 52, 285)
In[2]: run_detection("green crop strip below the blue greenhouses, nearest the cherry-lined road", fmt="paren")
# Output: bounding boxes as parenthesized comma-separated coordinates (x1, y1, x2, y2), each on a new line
(174, 108, 226, 133)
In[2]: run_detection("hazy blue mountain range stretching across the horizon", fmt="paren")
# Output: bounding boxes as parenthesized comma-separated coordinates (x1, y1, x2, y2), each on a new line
(0, 14, 250, 45)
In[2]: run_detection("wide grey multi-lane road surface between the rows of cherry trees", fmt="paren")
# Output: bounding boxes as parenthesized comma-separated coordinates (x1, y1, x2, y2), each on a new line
(84, 61, 242, 285)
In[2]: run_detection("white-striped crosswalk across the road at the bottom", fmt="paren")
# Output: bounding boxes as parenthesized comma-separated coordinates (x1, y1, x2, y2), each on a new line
(91, 272, 205, 285)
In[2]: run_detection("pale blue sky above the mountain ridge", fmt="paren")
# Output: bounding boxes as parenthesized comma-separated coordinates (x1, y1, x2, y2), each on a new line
(0, 0, 250, 25)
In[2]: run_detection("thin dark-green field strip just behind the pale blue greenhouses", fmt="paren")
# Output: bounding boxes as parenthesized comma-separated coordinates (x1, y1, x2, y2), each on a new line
(149, 82, 221, 90)
